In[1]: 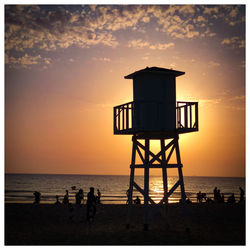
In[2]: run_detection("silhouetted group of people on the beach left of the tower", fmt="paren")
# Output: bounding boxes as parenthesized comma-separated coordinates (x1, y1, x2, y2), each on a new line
(33, 186, 101, 222)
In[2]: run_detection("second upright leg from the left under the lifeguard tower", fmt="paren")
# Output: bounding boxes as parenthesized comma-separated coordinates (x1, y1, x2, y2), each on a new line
(143, 139, 149, 231)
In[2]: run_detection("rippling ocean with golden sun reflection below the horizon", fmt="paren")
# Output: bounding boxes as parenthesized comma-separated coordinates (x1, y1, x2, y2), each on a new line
(5, 174, 245, 204)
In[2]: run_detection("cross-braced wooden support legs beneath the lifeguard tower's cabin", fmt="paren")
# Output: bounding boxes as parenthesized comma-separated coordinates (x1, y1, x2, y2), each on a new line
(127, 135, 187, 230)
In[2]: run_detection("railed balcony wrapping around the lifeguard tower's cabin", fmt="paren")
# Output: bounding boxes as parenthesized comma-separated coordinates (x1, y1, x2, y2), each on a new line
(114, 101, 198, 134)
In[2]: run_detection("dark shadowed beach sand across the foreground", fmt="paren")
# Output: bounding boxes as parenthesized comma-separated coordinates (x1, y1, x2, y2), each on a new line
(5, 203, 245, 245)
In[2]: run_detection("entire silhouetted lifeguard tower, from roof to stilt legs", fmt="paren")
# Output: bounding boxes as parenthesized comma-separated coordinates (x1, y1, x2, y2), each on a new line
(114, 67, 198, 228)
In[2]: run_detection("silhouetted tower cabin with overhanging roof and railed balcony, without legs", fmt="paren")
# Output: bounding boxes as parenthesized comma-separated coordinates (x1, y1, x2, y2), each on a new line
(114, 67, 198, 139)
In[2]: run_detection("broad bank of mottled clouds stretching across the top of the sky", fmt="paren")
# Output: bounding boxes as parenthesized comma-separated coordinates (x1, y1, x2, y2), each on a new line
(5, 5, 245, 68)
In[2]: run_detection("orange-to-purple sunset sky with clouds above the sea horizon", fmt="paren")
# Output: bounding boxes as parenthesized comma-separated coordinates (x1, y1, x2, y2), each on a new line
(4, 5, 245, 177)
